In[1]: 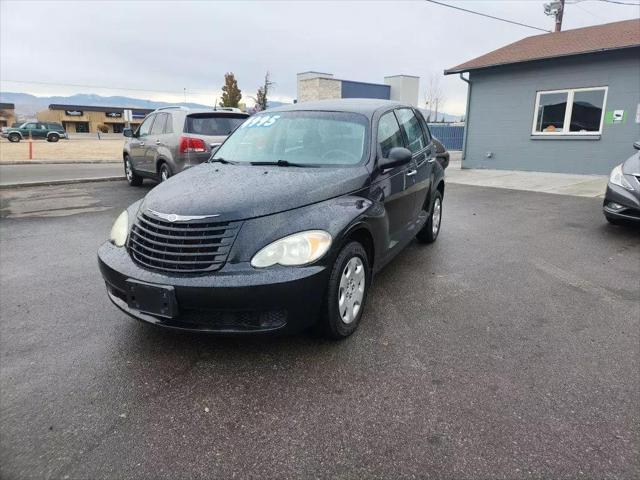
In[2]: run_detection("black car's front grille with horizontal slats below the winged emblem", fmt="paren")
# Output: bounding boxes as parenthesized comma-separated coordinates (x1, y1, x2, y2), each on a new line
(127, 213, 240, 273)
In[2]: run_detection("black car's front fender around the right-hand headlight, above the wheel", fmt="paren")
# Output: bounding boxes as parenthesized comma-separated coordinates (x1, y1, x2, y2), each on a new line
(227, 195, 374, 264)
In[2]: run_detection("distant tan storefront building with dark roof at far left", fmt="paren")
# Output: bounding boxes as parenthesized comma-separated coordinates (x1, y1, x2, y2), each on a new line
(37, 104, 153, 133)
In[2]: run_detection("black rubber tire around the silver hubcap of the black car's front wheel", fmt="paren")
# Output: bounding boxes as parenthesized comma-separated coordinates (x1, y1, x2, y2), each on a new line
(318, 242, 371, 340)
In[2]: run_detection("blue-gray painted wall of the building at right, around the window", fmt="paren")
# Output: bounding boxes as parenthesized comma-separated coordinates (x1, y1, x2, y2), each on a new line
(463, 48, 640, 175)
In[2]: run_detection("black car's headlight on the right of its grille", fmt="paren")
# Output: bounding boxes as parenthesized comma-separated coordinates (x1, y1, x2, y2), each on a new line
(251, 230, 331, 268)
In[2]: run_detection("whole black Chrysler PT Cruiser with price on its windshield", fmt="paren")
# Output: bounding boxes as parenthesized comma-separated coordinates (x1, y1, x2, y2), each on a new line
(98, 99, 444, 338)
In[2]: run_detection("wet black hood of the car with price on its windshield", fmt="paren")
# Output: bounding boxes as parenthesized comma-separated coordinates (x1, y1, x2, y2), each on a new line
(142, 163, 369, 221)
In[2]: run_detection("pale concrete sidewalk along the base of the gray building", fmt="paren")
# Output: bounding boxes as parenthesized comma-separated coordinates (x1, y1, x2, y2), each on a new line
(445, 152, 608, 197)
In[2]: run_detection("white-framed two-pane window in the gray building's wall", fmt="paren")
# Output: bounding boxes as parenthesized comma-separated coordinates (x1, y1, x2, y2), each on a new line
(531, 87, 607, 135)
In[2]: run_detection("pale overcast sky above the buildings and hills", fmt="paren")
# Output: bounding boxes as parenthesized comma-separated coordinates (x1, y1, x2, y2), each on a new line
(0, 0, 640, 114)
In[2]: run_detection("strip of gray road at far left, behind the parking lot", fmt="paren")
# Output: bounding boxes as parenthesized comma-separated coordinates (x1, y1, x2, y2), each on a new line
(0, 163, 124, 185)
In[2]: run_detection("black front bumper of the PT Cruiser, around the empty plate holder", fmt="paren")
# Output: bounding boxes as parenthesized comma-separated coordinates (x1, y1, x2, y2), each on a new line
(98, 242, 327, 333)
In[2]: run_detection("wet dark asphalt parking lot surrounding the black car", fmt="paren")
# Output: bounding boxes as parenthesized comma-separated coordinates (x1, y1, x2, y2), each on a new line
(0, 182, 640, 479)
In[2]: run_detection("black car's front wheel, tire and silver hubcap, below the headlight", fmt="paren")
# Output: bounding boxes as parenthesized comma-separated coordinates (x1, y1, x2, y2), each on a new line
(320, 242, 371, 339)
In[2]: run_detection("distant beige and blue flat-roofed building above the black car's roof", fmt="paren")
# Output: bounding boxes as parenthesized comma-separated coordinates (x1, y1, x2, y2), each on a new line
(297, 71, 420, 106)
